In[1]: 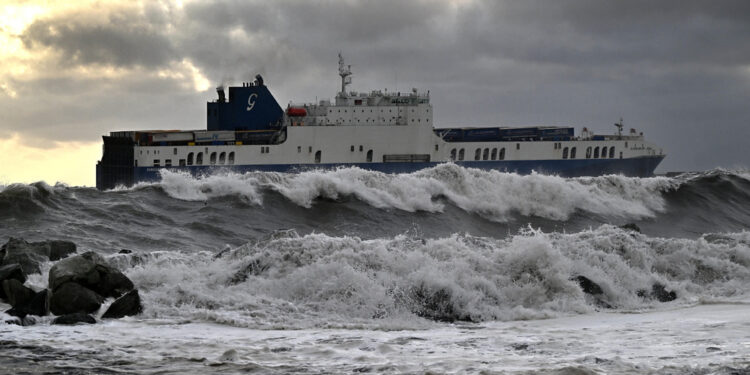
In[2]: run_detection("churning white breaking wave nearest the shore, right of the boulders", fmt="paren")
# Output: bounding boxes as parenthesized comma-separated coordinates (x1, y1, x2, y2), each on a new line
(119, 225, 750, 328)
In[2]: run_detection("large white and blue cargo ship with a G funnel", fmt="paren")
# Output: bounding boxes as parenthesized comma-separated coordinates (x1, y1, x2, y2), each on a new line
(96, 55, 665, 190)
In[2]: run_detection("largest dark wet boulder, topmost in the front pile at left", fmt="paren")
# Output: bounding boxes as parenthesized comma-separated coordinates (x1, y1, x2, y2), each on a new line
(49, 251, 133, 297)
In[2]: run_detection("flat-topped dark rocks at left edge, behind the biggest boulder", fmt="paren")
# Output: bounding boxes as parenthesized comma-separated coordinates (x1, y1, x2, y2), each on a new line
(0, 237, 76, 274)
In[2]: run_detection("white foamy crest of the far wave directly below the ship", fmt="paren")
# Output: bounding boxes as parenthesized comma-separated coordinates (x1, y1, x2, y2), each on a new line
(156, 164, 677, 221)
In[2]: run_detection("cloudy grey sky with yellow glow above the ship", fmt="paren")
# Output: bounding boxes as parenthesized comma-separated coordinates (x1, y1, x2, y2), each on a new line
(0, 0, 750, 180)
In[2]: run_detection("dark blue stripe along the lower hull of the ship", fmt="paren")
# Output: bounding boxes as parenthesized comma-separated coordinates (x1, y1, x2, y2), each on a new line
(133, 156, 664, 182)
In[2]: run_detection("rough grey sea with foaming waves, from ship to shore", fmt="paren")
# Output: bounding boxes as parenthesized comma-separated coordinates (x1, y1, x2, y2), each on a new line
(0, 164, 750, 375)
